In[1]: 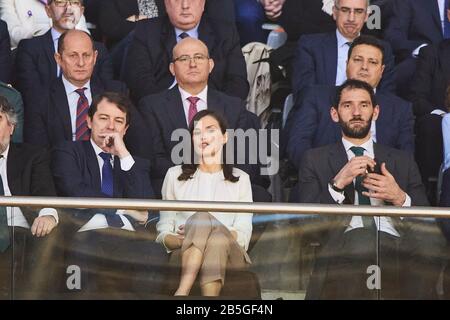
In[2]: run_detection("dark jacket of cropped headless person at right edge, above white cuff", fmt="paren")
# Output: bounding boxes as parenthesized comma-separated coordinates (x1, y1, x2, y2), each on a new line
(411, 40, 450, 116)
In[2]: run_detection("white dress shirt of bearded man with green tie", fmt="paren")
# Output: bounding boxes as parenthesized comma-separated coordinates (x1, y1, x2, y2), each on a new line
(328, 138, 411, 237)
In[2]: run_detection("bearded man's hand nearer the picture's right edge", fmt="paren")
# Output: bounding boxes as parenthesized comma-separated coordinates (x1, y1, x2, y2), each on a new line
(363, 162, 406, 207)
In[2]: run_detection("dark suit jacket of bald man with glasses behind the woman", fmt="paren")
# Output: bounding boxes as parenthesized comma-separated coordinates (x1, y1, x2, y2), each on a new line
(127, 86, 259, 191)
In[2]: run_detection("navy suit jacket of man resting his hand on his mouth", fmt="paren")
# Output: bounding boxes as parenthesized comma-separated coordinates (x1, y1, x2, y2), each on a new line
(52, 141, 153, 225)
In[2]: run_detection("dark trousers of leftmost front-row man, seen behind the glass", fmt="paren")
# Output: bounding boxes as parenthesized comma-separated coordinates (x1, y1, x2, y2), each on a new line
(0, 227, 63, 299)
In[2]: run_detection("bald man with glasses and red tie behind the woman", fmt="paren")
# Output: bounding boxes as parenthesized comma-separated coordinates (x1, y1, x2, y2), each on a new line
(129, 38, 263, 198)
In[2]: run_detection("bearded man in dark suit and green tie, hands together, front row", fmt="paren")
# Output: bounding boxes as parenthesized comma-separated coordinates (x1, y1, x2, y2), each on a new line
(299, 80, 440, 299)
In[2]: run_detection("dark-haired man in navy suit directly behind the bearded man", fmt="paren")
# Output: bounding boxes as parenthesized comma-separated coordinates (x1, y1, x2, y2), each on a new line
(286, 36, 414, 168)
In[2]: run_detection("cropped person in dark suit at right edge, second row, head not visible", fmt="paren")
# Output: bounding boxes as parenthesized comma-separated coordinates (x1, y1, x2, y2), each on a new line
(411, 39, 450, 201)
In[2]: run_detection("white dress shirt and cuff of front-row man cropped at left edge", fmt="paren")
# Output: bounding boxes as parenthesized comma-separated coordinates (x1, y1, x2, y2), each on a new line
(0, 146, 59, 229)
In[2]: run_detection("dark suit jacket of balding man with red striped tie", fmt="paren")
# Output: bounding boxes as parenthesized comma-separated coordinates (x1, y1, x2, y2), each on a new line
(24, 78, 125, 147)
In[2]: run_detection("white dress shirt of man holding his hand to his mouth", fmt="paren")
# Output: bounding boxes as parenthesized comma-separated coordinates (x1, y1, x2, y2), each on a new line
(78, 140, 134, 232)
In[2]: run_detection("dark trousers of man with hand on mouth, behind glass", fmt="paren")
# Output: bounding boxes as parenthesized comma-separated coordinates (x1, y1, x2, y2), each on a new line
(66, 228, 168, 299)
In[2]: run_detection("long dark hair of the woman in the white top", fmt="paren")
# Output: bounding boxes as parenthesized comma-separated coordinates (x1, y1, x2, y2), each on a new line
(178, 110, 239, 182)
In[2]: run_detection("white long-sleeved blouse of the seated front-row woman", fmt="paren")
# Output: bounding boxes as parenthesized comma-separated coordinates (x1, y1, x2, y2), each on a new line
(156, 166, 253, 252)
